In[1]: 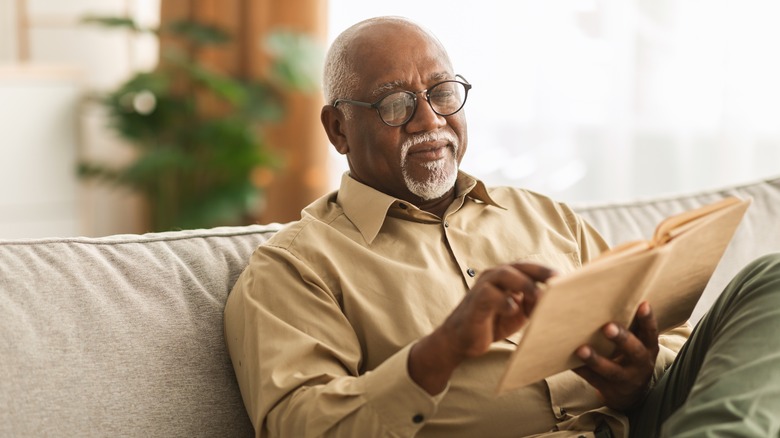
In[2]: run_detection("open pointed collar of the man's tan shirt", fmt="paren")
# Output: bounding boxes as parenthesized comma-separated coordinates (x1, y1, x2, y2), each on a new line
(336, 171, 504, 243)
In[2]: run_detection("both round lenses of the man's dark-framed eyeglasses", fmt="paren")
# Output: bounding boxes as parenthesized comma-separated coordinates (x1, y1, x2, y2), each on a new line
(378, 81, 466, 126)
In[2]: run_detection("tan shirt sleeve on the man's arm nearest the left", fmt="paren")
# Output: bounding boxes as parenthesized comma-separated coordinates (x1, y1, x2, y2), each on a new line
(225, 247, 446, 437)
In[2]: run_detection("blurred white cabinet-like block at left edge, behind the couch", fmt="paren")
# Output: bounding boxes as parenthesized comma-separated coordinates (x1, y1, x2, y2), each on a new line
(0, 67, 81, 238)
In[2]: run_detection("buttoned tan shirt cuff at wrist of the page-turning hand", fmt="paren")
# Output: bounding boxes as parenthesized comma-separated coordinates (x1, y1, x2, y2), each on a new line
(364, 345, 449, 436)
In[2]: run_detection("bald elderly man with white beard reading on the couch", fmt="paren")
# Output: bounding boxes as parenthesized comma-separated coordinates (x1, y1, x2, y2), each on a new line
(225, 17, 780, 437)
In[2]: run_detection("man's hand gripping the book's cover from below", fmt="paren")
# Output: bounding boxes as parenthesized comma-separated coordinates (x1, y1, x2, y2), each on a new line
(574, 302, 658, 411)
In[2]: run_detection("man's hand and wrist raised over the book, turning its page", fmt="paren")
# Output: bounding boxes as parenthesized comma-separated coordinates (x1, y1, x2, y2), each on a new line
(408, 263, 553, 394)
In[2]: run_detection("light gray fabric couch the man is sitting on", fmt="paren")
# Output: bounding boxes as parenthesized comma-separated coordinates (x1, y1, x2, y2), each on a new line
(0, 178, 780, 437)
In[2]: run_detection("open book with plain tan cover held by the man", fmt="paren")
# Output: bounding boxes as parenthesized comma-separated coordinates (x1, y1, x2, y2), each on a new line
(498, 197, 750, 392)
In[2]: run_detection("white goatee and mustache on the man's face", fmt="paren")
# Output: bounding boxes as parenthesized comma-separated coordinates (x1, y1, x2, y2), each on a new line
(401, 132, 458, 201)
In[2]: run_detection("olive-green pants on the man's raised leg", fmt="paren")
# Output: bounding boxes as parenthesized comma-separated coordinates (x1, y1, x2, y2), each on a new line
(631, 254, 780, 438)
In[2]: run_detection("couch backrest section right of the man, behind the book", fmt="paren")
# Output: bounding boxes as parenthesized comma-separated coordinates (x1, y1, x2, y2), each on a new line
(573, 178, 780, 322)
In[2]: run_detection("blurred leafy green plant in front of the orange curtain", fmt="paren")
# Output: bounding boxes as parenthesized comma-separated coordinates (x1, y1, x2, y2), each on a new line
(78, 17, 319, 231)
